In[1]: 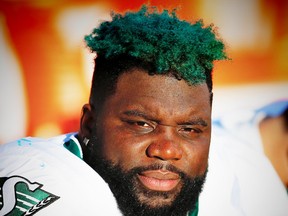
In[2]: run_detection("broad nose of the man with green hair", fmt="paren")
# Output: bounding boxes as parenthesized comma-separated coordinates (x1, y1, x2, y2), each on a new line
(146, 127, 183, 160)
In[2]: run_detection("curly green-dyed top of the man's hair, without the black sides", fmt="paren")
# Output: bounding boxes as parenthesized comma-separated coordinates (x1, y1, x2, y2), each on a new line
(85, 6, 227, 85)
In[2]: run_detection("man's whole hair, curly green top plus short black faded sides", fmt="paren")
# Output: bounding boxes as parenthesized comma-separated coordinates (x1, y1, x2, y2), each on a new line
(85, 6, 228, 111)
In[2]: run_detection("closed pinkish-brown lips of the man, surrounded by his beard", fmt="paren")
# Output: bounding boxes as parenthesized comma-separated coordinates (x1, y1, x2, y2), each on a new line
(138, 170, 180, 191)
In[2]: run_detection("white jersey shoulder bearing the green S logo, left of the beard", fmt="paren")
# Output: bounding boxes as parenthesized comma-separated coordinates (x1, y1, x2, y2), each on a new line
(0, 134, 121, 216)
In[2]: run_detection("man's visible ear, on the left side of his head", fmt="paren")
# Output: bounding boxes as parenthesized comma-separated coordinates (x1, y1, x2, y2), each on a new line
(79, 104, 96, 139)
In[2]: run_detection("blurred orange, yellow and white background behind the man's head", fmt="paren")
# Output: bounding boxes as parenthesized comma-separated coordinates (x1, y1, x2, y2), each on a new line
(0, 0, 288, 143)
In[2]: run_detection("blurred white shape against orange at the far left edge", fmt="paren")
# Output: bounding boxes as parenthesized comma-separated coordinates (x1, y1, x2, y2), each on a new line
(0, 14, 27, 144)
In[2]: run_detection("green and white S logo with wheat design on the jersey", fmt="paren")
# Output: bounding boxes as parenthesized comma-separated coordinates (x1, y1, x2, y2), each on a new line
(0, 176, 60, 216)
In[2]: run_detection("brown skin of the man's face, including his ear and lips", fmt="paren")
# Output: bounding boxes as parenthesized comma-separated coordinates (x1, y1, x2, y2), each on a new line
(79, 69, 211, 207)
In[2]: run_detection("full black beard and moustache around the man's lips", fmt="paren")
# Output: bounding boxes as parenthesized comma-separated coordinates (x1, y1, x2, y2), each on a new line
(86, 138, 207, 216)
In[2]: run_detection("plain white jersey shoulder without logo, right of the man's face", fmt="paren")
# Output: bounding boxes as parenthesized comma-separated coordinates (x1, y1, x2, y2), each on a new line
(199, 106, 288, 216)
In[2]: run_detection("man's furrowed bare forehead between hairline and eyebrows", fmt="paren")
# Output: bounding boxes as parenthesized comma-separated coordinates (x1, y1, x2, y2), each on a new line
(107, 69, 211, 119)
